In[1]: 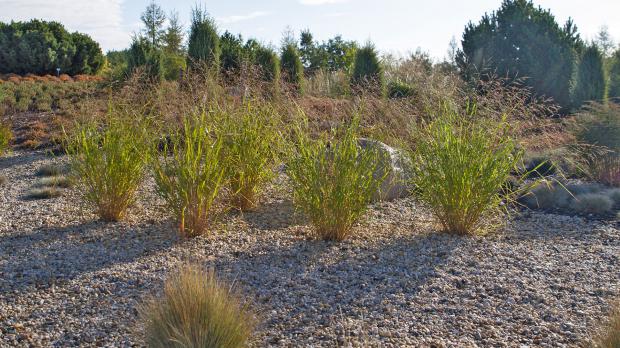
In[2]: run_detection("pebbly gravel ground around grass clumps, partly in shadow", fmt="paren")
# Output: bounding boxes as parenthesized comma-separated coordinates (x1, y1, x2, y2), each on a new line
(0, 152, 620, 347)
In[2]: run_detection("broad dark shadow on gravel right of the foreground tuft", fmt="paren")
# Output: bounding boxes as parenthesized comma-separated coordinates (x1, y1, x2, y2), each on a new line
(211, 233, 465, 334)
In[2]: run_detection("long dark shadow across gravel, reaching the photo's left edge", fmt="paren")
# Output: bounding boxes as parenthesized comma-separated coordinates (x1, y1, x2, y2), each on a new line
(0, 221, 178, 292)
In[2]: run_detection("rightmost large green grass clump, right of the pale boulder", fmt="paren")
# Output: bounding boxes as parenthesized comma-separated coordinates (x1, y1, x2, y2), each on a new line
(412, 108, 523, 234)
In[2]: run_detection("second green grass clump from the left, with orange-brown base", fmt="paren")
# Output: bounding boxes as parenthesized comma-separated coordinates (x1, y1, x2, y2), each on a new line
(153, 111, 227, 237)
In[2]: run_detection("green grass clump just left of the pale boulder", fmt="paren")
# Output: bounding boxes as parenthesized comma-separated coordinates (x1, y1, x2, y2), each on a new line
(287, 120, 387, 241)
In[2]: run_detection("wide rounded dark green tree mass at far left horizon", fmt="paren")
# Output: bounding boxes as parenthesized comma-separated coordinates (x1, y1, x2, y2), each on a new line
(0, 20, 105, 75)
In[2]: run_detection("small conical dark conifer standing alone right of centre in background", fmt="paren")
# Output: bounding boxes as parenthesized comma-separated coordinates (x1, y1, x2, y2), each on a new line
(351, 43, 384, 94)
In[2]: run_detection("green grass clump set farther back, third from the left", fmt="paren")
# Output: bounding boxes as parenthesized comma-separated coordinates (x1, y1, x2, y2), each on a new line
(218, 103, 281, 210)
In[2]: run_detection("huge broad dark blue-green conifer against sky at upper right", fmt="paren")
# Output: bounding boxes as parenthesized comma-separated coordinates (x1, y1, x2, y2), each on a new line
(456, 0, 583, 110)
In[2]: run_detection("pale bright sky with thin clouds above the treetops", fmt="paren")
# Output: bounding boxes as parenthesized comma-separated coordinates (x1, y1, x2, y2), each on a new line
(0, 0, 620, 60)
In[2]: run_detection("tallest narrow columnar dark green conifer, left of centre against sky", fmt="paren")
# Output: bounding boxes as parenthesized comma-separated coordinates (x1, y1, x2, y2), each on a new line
(187, 7, 221, 70)
